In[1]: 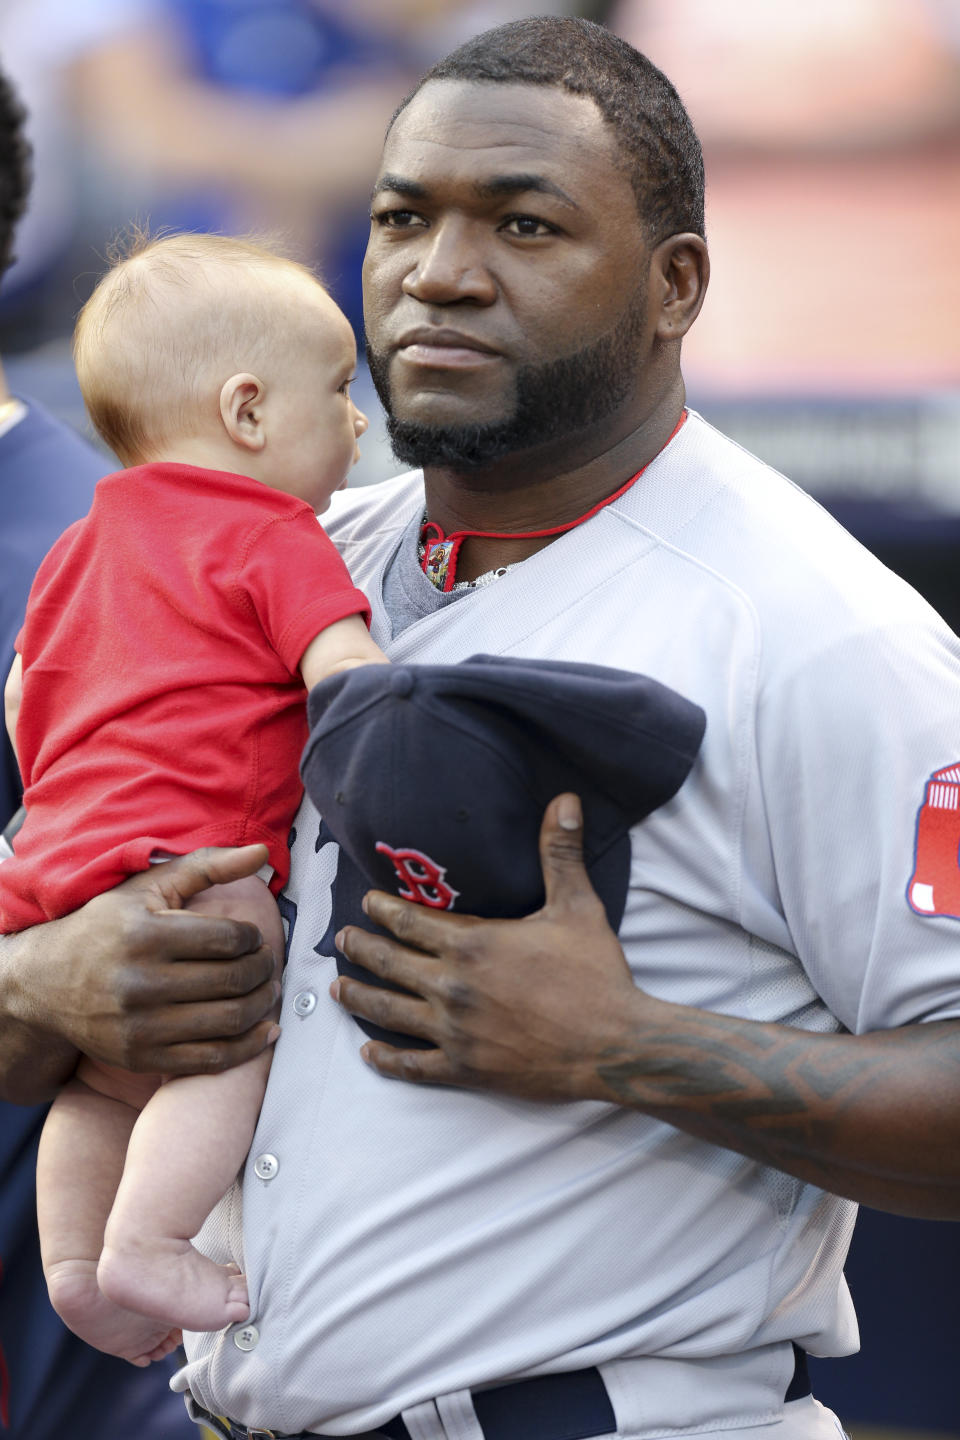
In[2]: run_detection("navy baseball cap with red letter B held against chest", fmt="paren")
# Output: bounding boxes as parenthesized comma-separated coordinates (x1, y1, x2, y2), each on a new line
(301, 655, 705, 1045)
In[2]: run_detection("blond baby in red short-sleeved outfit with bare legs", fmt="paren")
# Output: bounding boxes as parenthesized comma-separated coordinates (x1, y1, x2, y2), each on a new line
(0, 235, 386, 1365)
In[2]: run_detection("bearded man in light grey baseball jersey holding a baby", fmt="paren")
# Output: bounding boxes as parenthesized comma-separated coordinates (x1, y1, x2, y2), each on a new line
(0, 19, 960, 1440)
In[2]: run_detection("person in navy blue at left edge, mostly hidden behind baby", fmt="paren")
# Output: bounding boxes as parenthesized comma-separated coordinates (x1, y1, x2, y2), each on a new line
(0, 59, 197, 1440)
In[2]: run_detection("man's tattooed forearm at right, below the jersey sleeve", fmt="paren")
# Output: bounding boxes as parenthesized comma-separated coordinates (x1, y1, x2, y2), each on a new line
(594, 992, 960, 1220)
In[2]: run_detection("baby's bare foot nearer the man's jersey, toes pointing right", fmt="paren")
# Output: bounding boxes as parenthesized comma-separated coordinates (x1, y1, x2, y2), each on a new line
(96, 1238, 250, 1331)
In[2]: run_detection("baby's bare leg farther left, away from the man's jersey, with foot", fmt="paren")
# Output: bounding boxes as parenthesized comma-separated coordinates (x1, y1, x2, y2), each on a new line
(36, 1060, 180, 1365)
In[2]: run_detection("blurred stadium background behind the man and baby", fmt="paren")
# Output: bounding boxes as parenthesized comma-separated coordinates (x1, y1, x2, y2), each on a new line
(0, 0, 960, 1440)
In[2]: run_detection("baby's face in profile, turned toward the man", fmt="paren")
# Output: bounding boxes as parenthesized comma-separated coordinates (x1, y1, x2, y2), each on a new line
(266, 282, 367, 514)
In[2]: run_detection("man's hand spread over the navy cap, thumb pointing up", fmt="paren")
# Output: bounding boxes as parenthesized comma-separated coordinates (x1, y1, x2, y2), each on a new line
(331, 795, 646, 1100)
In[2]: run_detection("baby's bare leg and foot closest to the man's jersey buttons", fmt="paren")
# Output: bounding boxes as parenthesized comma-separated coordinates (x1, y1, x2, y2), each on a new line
(98, 877, 284, 1331)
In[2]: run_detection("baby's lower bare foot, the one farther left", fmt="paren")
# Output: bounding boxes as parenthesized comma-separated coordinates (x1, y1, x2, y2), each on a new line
(46, 1260, 181, 1367)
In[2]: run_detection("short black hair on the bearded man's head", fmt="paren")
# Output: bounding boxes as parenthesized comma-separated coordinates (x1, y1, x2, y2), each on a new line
(391, 16, 705, 245)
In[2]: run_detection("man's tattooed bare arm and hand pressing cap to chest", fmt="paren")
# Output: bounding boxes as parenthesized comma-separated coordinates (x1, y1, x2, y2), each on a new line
(331, 795, 960, 1220)
